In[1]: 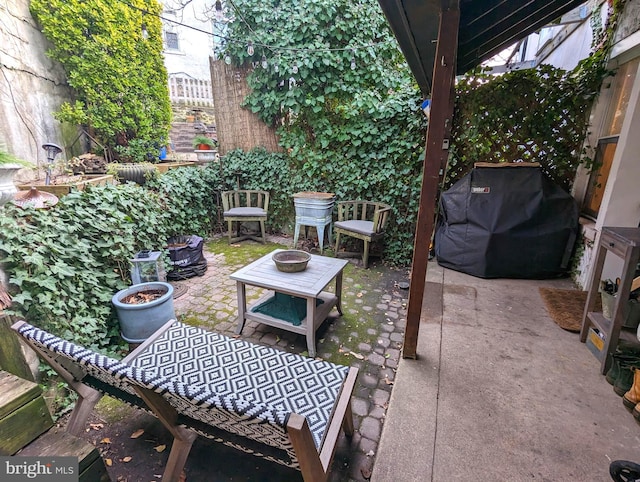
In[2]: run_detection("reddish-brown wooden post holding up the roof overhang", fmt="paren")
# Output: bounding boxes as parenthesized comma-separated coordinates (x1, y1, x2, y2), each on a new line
(402, 1, 460, 359)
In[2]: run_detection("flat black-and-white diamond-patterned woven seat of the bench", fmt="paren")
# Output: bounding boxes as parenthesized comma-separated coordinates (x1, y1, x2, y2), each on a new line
(131, 322, 349, 448)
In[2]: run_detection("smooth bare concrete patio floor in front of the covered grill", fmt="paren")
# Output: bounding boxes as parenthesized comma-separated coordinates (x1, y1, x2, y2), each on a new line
(371, 263, 640, 482)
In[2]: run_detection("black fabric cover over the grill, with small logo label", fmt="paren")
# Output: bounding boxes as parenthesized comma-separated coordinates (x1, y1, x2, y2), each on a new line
(435, 166, 578, 279)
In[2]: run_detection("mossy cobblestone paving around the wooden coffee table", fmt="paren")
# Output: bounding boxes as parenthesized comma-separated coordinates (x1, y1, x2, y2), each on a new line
(172, 239, 408, 482)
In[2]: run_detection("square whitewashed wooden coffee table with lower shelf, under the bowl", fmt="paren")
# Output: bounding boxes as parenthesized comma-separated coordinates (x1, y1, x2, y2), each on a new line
(230, 249, 348, 357)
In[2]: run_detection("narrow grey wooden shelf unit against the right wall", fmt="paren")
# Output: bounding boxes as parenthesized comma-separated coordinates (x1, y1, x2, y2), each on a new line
(580, 227, 640, 375)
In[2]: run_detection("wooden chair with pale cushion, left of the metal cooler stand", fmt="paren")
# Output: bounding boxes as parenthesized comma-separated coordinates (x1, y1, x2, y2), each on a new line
(222, 190, 269, 244)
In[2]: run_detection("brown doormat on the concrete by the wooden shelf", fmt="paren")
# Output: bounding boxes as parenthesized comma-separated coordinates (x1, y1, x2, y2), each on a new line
(539, 288, 602, 332)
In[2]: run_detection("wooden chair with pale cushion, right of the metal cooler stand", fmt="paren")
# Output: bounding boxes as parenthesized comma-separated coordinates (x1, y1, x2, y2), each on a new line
(334, 201, 391, 269)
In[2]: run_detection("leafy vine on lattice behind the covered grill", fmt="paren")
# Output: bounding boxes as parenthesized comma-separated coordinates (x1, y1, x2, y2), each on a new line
(445, 0, 625, 191)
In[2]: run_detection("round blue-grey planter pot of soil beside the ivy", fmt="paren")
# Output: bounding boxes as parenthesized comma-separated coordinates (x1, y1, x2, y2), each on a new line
(111, 281, 176, 343)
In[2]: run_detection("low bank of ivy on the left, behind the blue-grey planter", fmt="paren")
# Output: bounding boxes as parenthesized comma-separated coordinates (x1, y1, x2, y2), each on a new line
(0, 168, 219, 351)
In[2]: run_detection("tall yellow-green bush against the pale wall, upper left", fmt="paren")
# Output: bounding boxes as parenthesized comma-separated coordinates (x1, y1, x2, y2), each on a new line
(30, 0, 171, 160)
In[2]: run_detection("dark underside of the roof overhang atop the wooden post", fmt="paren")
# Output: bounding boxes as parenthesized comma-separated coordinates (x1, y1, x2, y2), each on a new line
(378, 0, 584, 96)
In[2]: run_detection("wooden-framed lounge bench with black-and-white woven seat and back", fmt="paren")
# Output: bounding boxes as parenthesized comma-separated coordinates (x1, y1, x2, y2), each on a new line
(12, 320, 358, 482)
